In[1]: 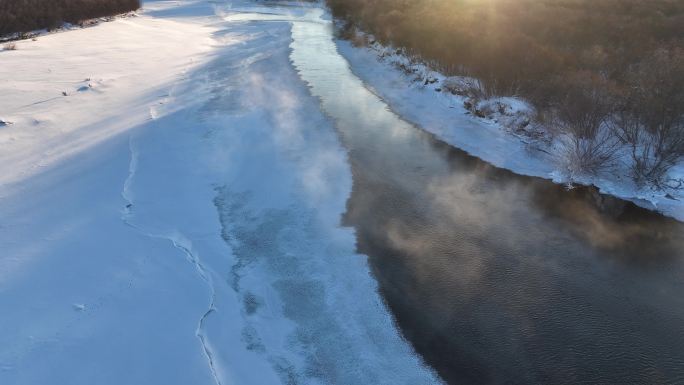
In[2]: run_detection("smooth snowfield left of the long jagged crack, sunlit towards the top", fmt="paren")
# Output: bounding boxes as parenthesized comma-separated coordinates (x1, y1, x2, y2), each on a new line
(0, 2, 219, 384)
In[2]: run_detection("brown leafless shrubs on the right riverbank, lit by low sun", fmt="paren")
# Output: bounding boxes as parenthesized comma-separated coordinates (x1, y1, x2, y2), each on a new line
(328, 0, 684, 185)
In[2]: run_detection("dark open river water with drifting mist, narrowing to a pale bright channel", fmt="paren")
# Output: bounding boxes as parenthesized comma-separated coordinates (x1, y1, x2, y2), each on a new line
(292, 23, 684, 384)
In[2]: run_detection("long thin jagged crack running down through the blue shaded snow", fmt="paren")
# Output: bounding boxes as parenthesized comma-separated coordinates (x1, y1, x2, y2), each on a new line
(121, 136, 221, 385)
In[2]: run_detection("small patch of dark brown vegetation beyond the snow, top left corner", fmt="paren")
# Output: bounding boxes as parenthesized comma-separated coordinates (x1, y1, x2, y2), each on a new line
(0, 0, 140, 36)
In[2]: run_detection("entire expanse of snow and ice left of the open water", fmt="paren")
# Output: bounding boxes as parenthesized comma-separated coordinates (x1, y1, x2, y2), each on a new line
(0, 0, 439, 385)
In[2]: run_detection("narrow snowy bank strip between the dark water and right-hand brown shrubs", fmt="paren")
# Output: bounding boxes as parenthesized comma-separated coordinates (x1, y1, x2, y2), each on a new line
(336, 39, 684, 221)
